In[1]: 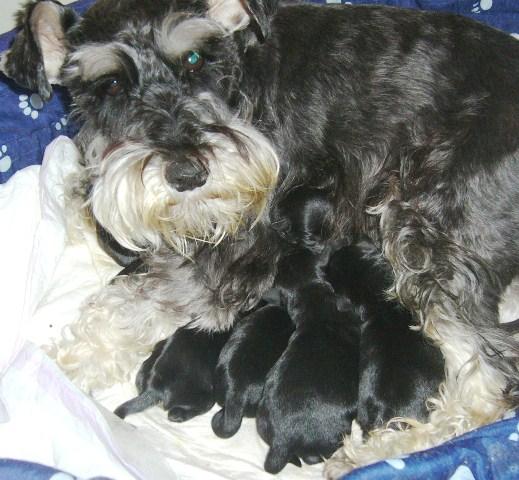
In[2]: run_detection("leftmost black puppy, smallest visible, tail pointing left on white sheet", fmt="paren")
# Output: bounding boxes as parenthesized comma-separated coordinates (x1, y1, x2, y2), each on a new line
(114, 325, 229, 422)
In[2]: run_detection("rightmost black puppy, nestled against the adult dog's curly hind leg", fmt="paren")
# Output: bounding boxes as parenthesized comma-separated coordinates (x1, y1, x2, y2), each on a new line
(326, 241, 445, 432)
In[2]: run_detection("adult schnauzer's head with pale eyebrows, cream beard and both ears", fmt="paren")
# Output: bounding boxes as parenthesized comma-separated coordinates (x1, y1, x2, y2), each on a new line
(3, 0, 278, 252)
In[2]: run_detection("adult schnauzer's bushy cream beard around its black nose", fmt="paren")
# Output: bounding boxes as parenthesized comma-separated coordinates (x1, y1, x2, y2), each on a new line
(87, 119, 279, 255)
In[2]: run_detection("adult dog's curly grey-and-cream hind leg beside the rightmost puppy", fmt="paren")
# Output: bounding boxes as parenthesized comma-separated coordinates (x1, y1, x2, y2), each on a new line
(327, 201, 519, 478)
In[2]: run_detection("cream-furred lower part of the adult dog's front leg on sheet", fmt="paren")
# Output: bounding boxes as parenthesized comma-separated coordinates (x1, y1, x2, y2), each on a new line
(45, 275, 178, 392)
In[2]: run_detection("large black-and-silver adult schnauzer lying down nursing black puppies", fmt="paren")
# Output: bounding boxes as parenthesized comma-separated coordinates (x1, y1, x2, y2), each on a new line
(1, 0, 519, 477)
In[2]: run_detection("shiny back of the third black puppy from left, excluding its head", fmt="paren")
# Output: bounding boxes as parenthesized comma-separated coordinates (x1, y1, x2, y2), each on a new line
(256, 300, 359, 473)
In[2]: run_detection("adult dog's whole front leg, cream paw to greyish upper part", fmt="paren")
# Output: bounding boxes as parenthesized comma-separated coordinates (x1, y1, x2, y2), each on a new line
(49, 252, 240, 391)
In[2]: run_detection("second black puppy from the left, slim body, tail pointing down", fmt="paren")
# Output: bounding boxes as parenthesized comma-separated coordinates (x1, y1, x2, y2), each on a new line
(211, 305, 294, 438)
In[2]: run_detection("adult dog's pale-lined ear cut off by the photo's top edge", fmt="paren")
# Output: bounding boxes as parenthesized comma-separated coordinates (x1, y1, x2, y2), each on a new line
(207, 0, 278, 42)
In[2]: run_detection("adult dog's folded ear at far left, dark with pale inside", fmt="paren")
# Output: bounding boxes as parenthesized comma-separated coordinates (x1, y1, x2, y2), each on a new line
(0, 0, 78, 100)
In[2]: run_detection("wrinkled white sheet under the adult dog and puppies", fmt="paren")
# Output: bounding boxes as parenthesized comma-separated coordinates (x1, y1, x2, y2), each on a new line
(0, 137, 322, 480)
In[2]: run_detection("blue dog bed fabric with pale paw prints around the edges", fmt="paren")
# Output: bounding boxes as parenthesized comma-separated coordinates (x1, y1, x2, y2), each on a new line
(0, 0, 519, 480)
